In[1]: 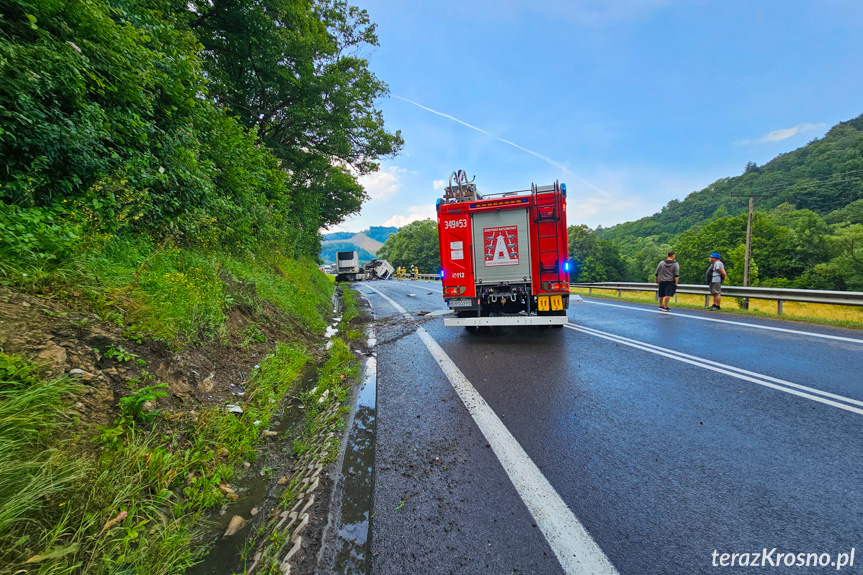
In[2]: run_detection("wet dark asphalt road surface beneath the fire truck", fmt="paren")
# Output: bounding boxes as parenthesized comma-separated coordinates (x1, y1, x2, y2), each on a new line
(355, 281, 863, 575)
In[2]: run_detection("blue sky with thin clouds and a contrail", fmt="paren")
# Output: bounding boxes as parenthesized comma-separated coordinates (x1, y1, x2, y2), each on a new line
(332, 0, 863, 231)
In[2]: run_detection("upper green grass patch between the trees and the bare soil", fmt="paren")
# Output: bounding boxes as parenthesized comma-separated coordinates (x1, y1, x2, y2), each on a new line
(0, 233, 334, 347)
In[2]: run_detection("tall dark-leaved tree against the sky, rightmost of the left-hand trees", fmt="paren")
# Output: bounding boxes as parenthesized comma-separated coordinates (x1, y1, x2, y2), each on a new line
(189, 0, 403, 226)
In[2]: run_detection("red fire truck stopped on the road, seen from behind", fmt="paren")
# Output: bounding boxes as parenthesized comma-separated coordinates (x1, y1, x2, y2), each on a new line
(437, 170, 569, 330)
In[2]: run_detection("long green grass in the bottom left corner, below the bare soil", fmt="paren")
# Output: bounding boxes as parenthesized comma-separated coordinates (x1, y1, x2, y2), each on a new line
(0, 344, 310, 575)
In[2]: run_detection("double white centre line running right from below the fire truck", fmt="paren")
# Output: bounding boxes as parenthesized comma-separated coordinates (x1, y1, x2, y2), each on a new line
(564, 324, 863, 415)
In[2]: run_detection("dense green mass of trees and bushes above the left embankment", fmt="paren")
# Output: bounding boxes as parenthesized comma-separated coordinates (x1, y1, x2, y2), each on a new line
(0, 0, 402, 257)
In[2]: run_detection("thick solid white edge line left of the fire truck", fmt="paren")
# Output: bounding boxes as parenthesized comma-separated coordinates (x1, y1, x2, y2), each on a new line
(366, 286, 617, 575)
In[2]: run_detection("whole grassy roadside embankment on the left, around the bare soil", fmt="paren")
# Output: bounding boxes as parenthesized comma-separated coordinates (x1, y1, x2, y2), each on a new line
(0, 238, 340, 575)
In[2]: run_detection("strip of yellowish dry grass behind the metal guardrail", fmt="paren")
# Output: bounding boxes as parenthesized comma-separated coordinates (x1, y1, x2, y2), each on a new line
(570, 288, 863, 329)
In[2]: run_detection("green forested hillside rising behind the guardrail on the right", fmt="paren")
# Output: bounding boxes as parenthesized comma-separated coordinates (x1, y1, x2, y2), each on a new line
(570, 116, 863, 289)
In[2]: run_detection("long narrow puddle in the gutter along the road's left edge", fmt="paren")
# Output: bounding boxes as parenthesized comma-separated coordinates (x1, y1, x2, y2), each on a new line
(332, 354, 377, 575)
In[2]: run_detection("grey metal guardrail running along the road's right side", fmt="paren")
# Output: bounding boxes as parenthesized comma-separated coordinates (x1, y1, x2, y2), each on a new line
(570, 282, 863, 315)
